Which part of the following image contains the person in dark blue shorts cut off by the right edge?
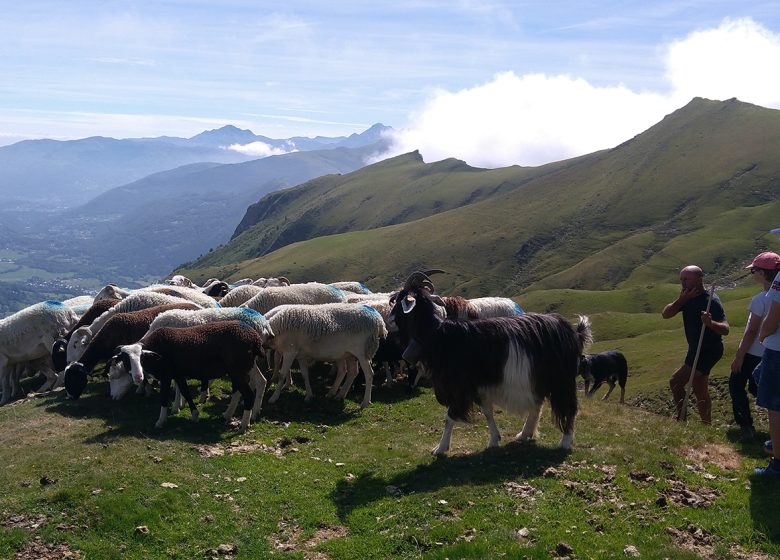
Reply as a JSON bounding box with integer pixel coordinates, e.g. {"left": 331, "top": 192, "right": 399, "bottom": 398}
{"left": 753, "top": 256, "right": 780, "bottom": 476}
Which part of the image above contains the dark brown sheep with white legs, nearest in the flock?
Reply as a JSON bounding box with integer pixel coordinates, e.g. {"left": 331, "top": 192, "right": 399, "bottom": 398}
{"left": 112, "top": 321, "right": 267, "bottom": 431}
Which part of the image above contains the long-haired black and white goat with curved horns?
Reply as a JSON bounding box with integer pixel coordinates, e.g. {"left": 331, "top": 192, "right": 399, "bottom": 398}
{"left": 392, "top": 280, "right": 591, "bottom": 455}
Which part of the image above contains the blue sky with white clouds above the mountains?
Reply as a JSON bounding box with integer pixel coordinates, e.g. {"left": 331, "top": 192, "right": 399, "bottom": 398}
{"left": 0, "top": 0, "right": 780, "bottom": 166}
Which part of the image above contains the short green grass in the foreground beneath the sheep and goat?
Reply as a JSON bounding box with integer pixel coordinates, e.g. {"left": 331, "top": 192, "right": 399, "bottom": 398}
{"left": 0, "top": 344, "right": 780, "bottom": 559}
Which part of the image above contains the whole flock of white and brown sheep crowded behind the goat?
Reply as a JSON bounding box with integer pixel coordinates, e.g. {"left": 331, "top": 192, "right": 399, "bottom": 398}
{"left": 0, "top": 271, "right": 523, "bottom": 440}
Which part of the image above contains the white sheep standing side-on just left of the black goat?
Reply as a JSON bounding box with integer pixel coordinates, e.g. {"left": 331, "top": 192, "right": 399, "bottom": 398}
{"left": 268, "top": 303, "right": 387, "bottom": 407}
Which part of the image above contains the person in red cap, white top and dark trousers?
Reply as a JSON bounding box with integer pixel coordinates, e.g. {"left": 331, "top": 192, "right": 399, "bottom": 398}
{"left": 729, "top": 251, "right": 780, "bottom": 438}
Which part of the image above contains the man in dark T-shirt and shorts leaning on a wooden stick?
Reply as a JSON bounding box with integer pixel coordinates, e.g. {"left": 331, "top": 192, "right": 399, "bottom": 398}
{"left": 661, "top": 265, "right": 729, "bottom": 424}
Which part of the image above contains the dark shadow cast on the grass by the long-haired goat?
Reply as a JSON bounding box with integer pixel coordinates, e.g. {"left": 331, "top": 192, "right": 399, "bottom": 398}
{"left": 331, "top": 442, "right": 569, "bottom": 521}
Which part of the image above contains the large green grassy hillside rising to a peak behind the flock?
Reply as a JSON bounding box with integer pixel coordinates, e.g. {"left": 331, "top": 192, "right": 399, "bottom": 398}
{"left": 179, "top": 99, "right": 780, "bottom": 295}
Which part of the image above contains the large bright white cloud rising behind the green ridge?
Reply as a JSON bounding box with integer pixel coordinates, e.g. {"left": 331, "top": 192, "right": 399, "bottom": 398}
{"left": 385, "top": 19, "right": 780, "bottom": 167}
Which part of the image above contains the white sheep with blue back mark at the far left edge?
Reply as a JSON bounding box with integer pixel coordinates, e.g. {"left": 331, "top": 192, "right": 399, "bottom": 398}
{"left": 0, "top": 301, "right": 78, "bottom": 404}
